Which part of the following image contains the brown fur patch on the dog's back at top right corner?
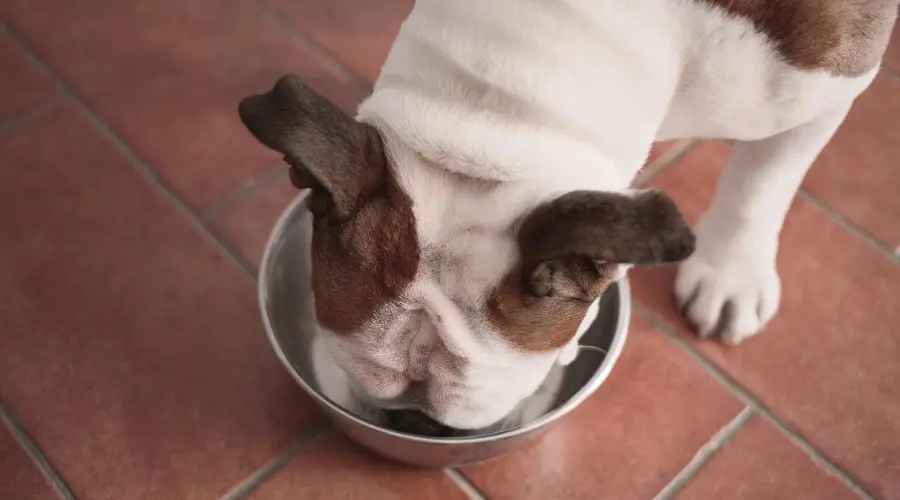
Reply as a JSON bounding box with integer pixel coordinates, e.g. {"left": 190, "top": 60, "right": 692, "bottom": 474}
{"left": 695, "top": 0, "right": 898, "bottom": 77}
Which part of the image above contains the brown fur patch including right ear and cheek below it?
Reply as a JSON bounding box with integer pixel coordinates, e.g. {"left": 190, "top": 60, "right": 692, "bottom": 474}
{"left": 487, "top": 191, "right": 694, "bottom": 352}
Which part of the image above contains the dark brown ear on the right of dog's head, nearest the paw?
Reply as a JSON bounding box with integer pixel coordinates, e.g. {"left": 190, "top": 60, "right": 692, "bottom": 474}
{"left": 518, "top": 190, "right": 694, "bottom": 301}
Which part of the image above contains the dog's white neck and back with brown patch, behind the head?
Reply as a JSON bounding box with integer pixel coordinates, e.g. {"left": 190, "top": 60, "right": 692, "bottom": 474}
{"left": 363, "top": 0, "right": 898, "bottom": 179}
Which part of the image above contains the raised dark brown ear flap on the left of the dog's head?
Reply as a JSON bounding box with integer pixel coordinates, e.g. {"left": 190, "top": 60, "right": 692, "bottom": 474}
{"left": 238, "top": 75, "right": 387, "bottom": 219}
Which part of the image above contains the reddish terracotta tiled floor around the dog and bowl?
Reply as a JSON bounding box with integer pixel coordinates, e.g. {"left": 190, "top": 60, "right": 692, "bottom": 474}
{"left": 0, "top": 0, "right": 900, "bottom": 500}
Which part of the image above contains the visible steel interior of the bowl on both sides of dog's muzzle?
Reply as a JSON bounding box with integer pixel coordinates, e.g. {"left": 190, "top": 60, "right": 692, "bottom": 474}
{"left": 259, "top": 195, "right": 630, "bottom": 439}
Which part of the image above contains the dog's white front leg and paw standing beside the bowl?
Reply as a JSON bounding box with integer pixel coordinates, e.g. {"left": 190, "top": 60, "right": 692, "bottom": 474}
{"left": 675, "top": 105, "right": 850, "bottom": 344}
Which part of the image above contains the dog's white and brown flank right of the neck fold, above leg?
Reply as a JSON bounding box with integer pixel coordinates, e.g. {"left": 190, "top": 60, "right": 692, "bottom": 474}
{"left": 657, "top": 0, "right": 898, "bottom": 140}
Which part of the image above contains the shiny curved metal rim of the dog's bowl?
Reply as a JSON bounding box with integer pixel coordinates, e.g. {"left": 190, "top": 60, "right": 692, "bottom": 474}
{"left": 256, "top": 190, "right": 631, "bottom": 445}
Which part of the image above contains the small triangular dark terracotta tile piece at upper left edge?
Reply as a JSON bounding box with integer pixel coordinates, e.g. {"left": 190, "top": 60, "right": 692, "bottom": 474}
{"left": 0, "top": 28, "right": 59, "bottom": 122}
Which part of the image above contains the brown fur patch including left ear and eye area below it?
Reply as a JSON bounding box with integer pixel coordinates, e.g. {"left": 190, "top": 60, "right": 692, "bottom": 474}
{"left": 238, "top": 76, "right": 420, "bottom": 333}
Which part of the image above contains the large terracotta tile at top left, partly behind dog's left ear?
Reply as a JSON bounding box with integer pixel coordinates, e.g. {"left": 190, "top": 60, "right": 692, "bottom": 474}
{"left": 0, "top": 0, "right": 362, "bottom": 210}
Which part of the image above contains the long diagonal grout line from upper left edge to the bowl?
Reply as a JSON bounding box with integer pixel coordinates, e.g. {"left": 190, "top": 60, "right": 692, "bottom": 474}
{"left": 0, "top": 21, "right": 256, "bottom": 279}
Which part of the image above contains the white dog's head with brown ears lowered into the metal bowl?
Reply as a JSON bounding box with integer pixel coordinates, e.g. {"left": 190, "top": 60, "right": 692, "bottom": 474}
{"left": 239, "top": 77, "right": 694, "bottom": 429}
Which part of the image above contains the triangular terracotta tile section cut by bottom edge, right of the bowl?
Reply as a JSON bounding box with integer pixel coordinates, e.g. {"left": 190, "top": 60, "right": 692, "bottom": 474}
{"left": 677, "top": 417, "right": 857, "bottom": 500}
